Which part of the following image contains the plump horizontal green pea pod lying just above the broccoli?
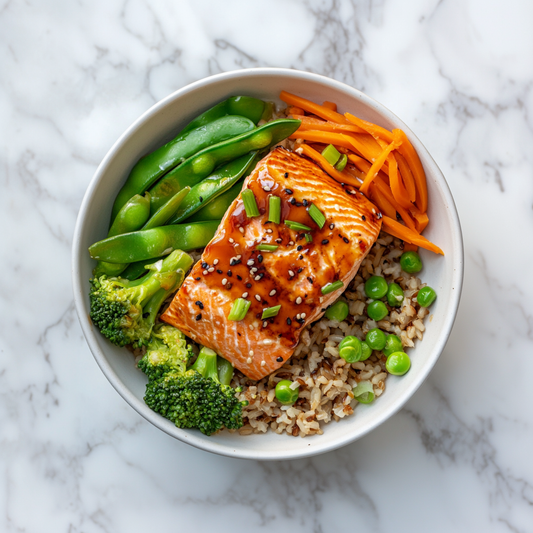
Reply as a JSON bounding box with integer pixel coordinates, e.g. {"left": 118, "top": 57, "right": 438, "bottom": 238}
{"left": 89, "top": 221, "right": 218, "bottom": 263}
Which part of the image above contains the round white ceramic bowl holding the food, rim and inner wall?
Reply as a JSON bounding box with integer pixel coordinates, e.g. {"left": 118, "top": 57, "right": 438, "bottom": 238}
{"left": 72, "top": 68, "right": 463, "bottom": 460}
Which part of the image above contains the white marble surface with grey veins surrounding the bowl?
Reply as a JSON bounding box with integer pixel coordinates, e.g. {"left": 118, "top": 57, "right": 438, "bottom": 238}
{"left": 0, "top": 0, "right": 533, "bottom": 533}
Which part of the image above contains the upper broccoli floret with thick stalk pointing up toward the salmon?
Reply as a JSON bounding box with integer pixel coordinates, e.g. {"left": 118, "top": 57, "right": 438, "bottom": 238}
{"left": 89, "top": 250, "right": 192, "bottom": 346}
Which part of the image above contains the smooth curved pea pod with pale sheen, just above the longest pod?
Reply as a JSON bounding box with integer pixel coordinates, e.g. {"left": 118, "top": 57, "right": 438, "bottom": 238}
{"left": 111, "top": 115, "right": 254, "bottom": 220}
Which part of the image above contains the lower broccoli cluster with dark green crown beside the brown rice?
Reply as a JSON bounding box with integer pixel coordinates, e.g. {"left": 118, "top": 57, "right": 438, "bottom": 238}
{"left": 139, "top": 326, "right": 246, "bottom": 435}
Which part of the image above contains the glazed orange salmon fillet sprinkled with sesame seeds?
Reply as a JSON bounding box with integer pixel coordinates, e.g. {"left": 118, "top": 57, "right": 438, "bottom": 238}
{"left": 161, "top": 148, "right": 381, "bottom": 380}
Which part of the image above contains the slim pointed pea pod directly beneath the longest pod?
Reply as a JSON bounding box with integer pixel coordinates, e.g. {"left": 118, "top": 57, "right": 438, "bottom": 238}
{"left": 165, "top": 152, "right": 262, "bottom": 224}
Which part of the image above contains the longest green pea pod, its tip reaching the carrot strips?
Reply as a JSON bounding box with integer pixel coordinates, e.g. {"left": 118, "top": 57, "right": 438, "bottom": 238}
{"left": 150, "top": 119, "right": 300, "bottom": 212}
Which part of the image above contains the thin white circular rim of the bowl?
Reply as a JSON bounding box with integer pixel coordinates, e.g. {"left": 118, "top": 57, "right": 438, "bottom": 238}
{"left": 72, "top": 67, "right": 464, "bottom": 460}
